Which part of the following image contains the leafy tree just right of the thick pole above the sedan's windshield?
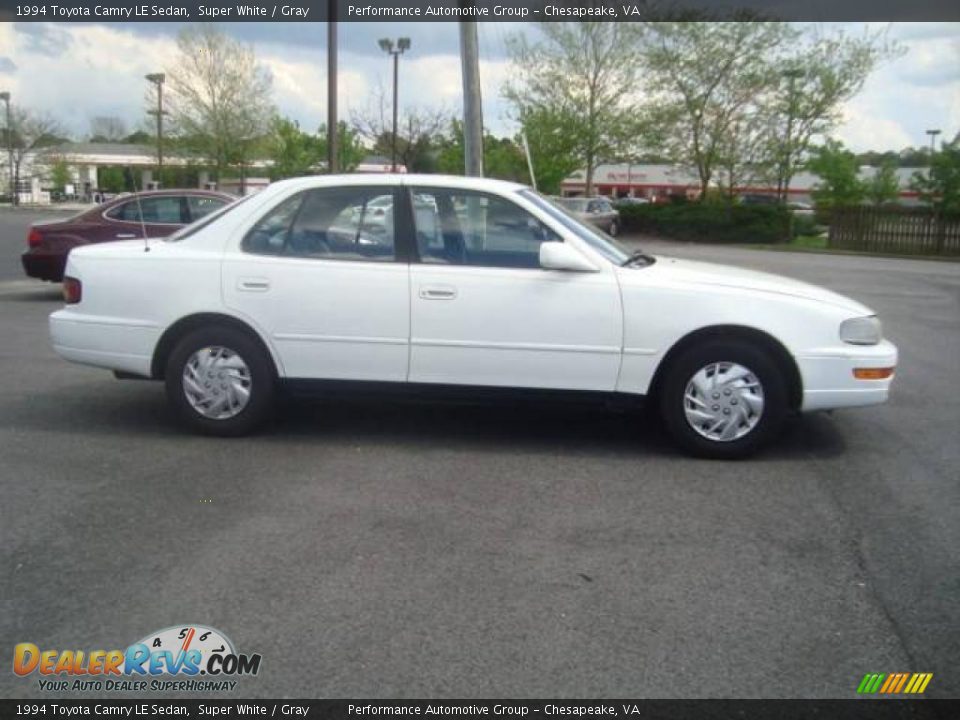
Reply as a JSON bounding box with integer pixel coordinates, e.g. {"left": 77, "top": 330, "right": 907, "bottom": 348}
{"left": 503, "top": 22, "right": 641, "bottom": 195}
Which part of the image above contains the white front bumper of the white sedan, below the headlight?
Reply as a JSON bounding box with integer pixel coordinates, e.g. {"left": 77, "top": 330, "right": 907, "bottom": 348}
{"left": 796, "top": 340, "right": 898, "bottom": 411}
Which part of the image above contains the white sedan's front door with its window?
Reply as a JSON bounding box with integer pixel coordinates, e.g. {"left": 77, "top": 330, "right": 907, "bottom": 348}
{"left": 409, "top": 187, "right": 622, "bottom": 390}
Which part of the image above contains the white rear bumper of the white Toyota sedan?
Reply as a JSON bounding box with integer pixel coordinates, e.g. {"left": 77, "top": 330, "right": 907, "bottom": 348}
{"left": 50, "top": 309, "right": 160, "bottom": 377}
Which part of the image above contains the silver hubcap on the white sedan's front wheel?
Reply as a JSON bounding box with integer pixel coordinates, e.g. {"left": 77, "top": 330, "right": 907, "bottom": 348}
{"left": 683, "top": 362, "right": 763, "bottom": 442}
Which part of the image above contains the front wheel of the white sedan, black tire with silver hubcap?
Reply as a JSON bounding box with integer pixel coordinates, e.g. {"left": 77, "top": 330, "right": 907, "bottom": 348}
{"left": 660, "top": 340, "right": 788, "bottom": 459}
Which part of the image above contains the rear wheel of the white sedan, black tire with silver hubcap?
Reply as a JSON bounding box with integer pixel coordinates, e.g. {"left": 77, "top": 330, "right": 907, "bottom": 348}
{"left": 164, "top": 325, "right": 276, "bottom": 437}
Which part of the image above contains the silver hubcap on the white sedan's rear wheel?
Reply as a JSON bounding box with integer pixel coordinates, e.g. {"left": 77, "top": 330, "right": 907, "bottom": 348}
{"left": 183, "top": 346, "right": 251, "bottom": 420}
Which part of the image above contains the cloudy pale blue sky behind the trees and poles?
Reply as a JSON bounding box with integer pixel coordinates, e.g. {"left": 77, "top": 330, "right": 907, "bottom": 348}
{"left": 0, "top": 22, "right": 960, "bottom": 152}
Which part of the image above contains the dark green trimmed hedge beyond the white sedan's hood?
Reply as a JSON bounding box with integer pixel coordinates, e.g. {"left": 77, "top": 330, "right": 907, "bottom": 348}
{"left": 620, "top": 202, "right": 790, "bottom": 243}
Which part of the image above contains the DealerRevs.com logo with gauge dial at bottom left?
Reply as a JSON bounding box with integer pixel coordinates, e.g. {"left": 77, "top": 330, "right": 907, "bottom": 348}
{"left": 13, "top": 624, "right": 261, "bottom": 692}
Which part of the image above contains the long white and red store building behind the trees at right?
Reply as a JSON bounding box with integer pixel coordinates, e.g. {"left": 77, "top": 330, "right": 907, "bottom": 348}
{"left": 560, "top": 164, "right": 926, "bottom": 205}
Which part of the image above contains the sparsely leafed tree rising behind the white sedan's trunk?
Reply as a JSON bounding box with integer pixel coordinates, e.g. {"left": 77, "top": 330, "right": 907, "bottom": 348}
{"left": 167, "top": 25, "right": 275, "bottom": 186}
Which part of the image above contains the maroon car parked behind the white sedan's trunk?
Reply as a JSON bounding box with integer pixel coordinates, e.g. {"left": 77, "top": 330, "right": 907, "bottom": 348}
{"left": 21, "top": 190, "right": 236, "bottom": 282}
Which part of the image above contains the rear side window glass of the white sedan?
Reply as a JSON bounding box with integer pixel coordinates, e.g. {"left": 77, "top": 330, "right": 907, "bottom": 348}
{"left": 243, "top": 187, "right": 394, "bottom": 260}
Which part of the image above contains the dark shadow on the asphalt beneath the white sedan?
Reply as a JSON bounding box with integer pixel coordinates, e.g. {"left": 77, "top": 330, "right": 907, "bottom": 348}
{"left": 0, "top": 381, "right": 846, "bottom": 462}
